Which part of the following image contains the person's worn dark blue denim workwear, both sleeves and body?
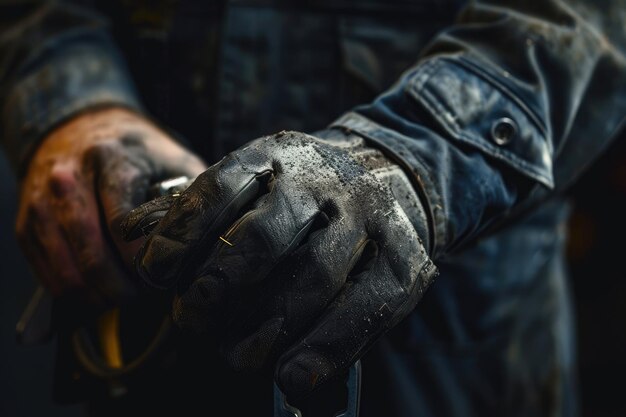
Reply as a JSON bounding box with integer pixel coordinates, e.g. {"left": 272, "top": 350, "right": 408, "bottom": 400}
{"left": 0, "top": 0, "right": 626, "bottom": 417}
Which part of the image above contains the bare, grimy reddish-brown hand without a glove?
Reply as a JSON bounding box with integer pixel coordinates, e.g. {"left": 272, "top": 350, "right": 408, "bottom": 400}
{"left": 16, "top": 108, "right": 206, "bottom": 312}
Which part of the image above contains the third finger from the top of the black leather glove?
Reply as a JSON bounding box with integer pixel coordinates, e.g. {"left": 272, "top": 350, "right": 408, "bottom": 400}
{"left": 217, "top": 221, "right": 368, "bottom": 369}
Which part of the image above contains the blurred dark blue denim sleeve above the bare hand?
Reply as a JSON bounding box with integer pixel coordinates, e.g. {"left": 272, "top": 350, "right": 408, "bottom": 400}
{"left": 0, "top": 1, "right": 141, "bottom": 176}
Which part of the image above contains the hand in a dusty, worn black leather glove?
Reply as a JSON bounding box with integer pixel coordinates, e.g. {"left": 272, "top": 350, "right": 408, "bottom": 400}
{"left": 125, "top": 131, "right": 436, "bottom": 399}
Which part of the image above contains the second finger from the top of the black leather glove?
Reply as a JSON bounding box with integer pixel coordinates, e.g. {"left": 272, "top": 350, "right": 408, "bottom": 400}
{"left": 174, "top": 182, "right": 328, "bottom": 333}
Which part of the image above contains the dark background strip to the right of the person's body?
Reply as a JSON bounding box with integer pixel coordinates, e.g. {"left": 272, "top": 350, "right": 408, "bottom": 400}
{"left": 568, "top": 129, "right": 626, "bottom": 417}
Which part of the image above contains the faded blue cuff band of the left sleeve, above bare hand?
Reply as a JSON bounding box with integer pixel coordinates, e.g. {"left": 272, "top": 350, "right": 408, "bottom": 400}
{"left": 1, "top": 39, "right": 143, "bottom": 178}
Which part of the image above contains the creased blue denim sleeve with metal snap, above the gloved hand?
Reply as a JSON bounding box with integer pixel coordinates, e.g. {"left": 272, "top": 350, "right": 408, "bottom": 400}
{"left": 331, "top": 0, "right": 626, "bottom": 256}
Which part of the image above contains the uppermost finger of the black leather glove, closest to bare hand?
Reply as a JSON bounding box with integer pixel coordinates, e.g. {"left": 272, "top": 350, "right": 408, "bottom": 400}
{"left": 135, "top": 150, "right": 274, "bottom": 288}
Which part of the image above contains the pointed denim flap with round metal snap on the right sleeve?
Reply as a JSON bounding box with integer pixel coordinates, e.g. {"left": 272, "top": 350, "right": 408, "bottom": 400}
{"left": 405, "top": 55, "right": 554, "bottom": 189}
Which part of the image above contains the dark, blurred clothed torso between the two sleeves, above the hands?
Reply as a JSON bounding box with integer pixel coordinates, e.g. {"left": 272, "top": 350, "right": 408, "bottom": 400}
{"left": 102, "top": 0, "right": 461, "bottom": 162}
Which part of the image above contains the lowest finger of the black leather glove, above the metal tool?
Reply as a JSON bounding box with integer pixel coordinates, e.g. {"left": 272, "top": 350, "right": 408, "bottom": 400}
{"left": 276, "top": 245, "right": 430, "bottom": 399}
